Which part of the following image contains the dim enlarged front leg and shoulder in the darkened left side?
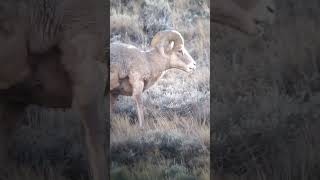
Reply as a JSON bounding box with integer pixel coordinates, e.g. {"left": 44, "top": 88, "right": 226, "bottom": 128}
{"left": 61, "top": 34, "right": 109, "bottom": 180}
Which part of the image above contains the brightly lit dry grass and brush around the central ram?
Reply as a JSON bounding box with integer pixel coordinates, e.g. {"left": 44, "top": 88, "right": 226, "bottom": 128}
{"left": 111, "top": 0, "right": 210, "bottom": 179}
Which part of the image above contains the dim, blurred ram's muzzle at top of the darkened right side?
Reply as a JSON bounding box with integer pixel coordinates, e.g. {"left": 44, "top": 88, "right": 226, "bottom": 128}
{"left": 211, "top": 0, "right": 275, "bottom": 35}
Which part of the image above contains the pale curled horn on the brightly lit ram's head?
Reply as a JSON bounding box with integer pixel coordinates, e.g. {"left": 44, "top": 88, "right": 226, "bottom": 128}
{"left": 151, "top": 30, "right": 184, "bottom": 49}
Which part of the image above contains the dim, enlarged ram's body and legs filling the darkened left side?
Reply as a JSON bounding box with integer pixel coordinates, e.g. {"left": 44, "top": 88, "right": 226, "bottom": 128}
{"left": 0, "top": 0, "right": 109, "bottom": 180}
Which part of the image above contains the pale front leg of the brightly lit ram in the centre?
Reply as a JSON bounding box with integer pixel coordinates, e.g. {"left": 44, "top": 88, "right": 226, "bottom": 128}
{"left": 130, "top": 81, "right": 144, "bottom": 128}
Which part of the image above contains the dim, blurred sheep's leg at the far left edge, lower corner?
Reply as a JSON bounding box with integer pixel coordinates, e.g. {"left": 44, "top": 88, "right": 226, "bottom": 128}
{"left": 0, "top": 103, "right": 24, "bottom": 174}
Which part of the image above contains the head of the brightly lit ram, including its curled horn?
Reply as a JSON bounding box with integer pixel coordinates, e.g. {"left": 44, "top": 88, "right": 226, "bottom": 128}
{"left": 151, "top": 30, "right": 196, "bottom": 72}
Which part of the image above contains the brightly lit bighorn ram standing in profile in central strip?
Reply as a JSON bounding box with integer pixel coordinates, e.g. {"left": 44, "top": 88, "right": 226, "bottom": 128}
{"left": 110, "top": 30, "right": 196, "bottom": 127}
